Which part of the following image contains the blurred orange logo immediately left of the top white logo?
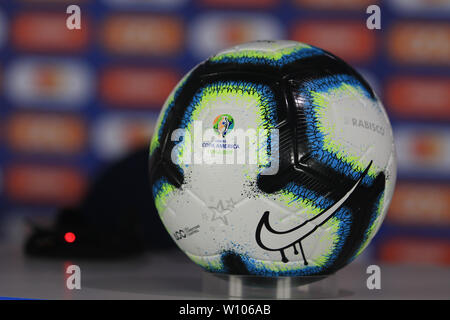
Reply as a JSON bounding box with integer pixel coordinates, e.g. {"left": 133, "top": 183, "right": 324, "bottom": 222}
{"left": 102, "top": 14, "right": 183, "bottom": 55}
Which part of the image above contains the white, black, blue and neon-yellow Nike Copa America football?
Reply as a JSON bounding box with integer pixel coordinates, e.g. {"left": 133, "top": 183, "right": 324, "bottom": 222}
{"left": 149, "top": 41, "right": 396, "bottom": 277}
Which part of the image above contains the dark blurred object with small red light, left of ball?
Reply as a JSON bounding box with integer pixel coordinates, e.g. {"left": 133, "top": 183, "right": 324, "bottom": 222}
{"left": 25, "top": 148, "right": 175, "bottom": 258}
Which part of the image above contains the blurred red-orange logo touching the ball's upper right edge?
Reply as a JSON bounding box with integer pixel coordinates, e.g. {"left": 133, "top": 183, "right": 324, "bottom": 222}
{"left": 292, "top": 20, "right": 376, "bottom": 62}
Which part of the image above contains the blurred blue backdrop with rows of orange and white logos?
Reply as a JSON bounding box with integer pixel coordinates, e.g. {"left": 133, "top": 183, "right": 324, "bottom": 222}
{"left": 0, "top": 0, "right": 450, "bottom": 265}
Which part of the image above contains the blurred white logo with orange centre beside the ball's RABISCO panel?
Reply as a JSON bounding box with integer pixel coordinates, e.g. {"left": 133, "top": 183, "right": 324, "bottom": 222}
{"left": 394, "top": 126, "right": 450, "bottom": 175}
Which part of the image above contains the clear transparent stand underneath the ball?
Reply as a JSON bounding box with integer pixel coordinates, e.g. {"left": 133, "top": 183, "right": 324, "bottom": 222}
{"left": 202, "top": 272, "right": 339, "bottom": 299}
